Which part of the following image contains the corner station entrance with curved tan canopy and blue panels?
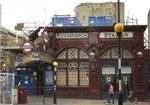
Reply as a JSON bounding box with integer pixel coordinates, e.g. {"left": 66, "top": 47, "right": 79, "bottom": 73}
{"left": 16, "top": 52, "right": 53, "bottom": 95}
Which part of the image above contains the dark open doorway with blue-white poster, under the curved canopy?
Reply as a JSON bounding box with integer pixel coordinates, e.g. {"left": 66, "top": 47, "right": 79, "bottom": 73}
{"left": 34, "top": 64, "right": 53, "bottom": 95}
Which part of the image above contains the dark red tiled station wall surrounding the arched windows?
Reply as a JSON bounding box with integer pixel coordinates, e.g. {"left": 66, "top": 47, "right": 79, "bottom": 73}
{"left": 29, "top": 25, "right": 146, "bottom": 100}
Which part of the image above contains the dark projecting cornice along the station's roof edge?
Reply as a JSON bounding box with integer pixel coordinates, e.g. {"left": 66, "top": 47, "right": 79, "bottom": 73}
{"left": 29, "top": 25, "right": 147, "bottom": 40}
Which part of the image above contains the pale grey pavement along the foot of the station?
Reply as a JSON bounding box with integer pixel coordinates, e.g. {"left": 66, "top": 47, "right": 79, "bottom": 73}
{"left": 14, "top": 96, "right": 150, "bottom": 105}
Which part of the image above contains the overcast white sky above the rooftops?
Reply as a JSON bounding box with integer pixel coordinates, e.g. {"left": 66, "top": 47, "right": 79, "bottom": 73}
{"left": 0, "top": 0, "right": 150, "bottom": 30}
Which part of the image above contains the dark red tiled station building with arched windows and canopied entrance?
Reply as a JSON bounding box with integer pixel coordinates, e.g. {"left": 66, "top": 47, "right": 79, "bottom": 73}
{"left": 16, "top": 25, "right": 150, "bottom": 100}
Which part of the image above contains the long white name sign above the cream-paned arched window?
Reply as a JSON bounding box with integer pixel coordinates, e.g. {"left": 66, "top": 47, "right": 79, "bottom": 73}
{"left": 56, "top": 33, "right": 88, "bottom": 39}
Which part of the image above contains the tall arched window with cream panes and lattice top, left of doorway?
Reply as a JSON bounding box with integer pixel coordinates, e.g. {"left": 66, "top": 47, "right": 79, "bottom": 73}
{"left": 57, "top": 47, "right": 89, "bottom": 86}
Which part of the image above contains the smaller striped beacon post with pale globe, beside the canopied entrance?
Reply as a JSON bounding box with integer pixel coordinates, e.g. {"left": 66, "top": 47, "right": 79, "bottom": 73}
{"left": 53, "top": 61, "right": 58, "bottom": 104}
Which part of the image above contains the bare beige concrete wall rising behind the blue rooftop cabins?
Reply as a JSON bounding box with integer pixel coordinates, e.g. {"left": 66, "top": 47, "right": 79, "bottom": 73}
{"left": 75, "top": 2, "right": 125, "bottom": 26}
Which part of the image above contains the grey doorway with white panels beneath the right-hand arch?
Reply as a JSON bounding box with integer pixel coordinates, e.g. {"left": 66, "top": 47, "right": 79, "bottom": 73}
{"left": 100, "top": 66, "right": 133, "bottom": 98}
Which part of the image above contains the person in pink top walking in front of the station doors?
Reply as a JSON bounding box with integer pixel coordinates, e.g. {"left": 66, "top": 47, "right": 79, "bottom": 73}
{"left": 108, "top": 82, "right": 115, "bottom": 104}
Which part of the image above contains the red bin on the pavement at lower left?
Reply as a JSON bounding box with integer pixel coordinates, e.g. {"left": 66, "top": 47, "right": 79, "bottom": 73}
{"left": 18, "top": 87, "right": 27, "bottom": 104}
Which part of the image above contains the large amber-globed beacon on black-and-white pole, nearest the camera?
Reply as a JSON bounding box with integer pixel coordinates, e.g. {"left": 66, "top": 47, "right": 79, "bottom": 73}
{"left": 114, "top": 23, "right": 124, "bottom": 105}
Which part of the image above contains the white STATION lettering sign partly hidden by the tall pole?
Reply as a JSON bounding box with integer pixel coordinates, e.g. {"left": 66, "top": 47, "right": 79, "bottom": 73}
{"left": 99, "top": 32, "right": 133, "bottom": 38}
